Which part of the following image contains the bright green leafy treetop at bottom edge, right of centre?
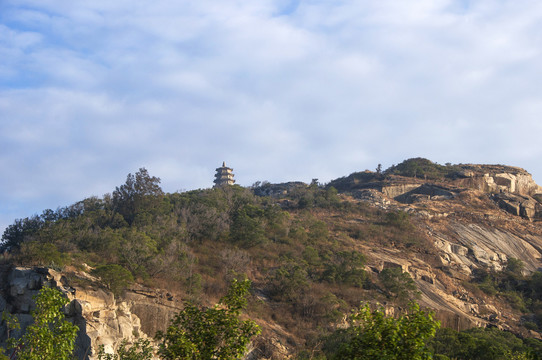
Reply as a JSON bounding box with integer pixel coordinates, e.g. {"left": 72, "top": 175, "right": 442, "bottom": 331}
{"left": 328, "top": 303, "right": 440, "bottom": 360}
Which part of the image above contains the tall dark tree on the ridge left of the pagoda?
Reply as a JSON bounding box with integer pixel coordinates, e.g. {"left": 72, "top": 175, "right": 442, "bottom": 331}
{"left": 113, "top": 168, "right": 164, "bottom": 224}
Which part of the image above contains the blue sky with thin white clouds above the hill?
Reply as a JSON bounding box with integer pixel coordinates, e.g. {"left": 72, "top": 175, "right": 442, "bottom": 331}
{"left": 0, "top": 0, "right": 542, "bottom": 233}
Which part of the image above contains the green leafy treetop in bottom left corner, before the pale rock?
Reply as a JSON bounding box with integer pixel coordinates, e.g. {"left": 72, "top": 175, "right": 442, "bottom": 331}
{"left": 2, "top": 287, "right": 78, "bottom": 360}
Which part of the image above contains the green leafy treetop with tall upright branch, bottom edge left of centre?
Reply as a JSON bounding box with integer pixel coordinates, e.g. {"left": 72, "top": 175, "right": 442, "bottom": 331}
{"left": 157, "top": 280, "right": 260, "bottom": 360}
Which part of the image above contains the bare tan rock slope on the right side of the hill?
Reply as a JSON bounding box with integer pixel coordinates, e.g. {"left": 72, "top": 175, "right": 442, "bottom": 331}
{"left": 332, "top": 165, "right": 542, "bottom": 337}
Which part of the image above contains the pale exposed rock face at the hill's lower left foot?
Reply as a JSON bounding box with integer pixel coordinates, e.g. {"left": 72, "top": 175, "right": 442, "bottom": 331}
{"left": 0, "top": 267, "right": 180, "bottom": 360}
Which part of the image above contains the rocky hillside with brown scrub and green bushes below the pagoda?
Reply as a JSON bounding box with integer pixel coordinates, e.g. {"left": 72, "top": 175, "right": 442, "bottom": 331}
{"left": 0, "top": 158, "right": 542, "bottom": 359}
